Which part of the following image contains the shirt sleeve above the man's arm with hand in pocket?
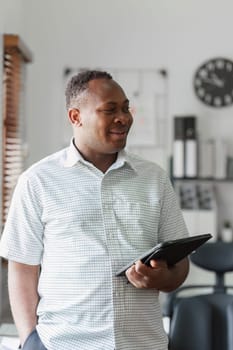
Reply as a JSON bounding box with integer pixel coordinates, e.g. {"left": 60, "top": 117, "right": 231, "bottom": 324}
{"left": 0, "top": 174, "right": 44, "bottom": 265}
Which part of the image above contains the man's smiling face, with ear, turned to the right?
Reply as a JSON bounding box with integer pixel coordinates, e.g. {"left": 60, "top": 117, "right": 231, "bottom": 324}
{"left": 74, "top": 79, "right": 133, "bottom": 155}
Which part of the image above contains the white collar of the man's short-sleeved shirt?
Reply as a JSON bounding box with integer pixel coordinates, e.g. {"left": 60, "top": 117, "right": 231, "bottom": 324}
{"left": 63, "top": 139, "right": 136, "bottom": 170}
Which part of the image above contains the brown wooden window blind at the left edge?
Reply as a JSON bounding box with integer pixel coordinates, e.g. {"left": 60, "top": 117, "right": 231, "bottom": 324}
{"left": 2, "top": 34, "right": 31, "bottom": 225}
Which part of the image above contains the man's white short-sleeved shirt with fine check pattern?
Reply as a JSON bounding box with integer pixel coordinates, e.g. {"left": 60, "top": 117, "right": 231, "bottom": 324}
{"left": 0, "top": 143, "right": 187, "bottom": 350}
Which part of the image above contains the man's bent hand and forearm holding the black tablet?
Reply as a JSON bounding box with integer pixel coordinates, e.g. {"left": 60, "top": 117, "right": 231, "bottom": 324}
{"left": 126, "top": 258, "right": 189, "bottom": 292}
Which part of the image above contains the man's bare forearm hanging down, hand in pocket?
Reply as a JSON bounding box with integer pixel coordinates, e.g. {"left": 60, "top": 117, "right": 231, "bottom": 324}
{"left": 8, "top": 261, "right": 39, "bottom": 344}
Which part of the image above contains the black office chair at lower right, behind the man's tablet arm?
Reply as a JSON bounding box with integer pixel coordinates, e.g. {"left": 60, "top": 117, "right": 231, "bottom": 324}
{"left": 163, "top": 241, "right": 233, "bottom": 350}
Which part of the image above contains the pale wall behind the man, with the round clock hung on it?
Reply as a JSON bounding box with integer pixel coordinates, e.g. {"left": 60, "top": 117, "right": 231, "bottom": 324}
{"left": 18, "top": 0, "right": 233, "bottom": 162}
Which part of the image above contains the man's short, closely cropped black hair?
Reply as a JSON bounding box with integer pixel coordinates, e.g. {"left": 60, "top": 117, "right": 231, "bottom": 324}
{"left": 65, "top": 70, "right": 112, "bottom": 109}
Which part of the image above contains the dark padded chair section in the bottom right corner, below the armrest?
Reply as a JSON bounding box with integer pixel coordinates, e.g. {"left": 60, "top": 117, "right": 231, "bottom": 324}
{"left": 169, "top": 294, "right": 233, "bottom": 350}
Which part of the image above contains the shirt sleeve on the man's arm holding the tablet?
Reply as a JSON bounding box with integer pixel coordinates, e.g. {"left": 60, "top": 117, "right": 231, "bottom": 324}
{"left": 158, "top": 175, "right": 188, "bottom": 242}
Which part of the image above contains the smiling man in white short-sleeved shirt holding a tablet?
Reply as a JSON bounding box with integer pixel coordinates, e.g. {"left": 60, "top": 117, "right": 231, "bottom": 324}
{"left": 1, "top": 71, "right": 188, "bottom": 350}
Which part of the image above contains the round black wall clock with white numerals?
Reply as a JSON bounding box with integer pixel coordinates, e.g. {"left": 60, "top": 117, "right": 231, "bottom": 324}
{"left": 194, "top": 57, "right": 233, "bottom": 108}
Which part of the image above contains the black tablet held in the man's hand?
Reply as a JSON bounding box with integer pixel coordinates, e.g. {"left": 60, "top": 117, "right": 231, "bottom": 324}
{"left": 116, "top": 233, "right": 212, "bottom": 276}
